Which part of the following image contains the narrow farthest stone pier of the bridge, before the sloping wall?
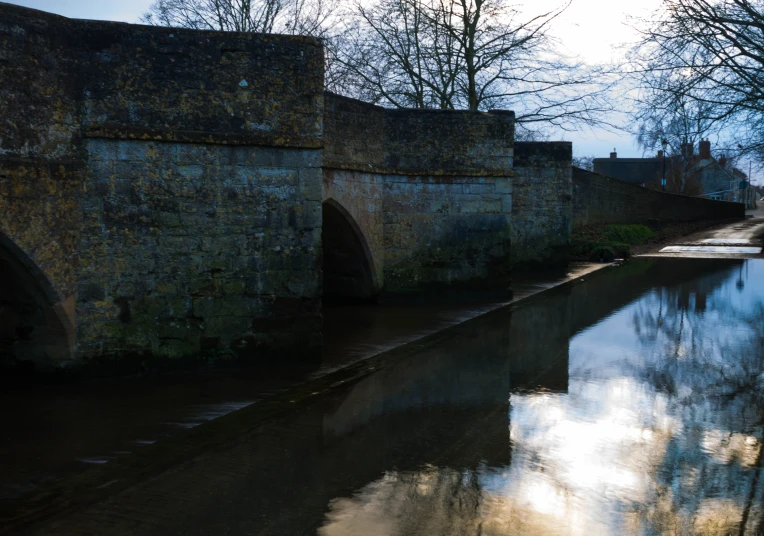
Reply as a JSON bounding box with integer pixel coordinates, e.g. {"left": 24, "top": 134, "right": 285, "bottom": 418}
{"left": 512, "top": 142, "right": 573, "bottom": 266}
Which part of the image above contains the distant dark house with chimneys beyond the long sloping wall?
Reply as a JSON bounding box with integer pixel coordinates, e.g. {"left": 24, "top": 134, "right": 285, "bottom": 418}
{"left": 593, "top": 140, "right": 758, "bottom": 208}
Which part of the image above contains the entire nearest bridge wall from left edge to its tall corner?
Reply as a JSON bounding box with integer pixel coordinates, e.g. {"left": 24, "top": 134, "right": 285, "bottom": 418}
{"left": 0, "top": 4, "right": 323, "bottom": 368}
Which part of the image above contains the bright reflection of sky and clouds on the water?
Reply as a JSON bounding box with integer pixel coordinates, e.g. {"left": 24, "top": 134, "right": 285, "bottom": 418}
{"left": 320, "top": 260, "right": 764, "bottom": 535}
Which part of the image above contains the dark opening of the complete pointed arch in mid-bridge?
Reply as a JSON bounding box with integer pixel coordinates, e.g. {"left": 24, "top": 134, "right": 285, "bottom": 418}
{"left": 321, "top": 198, "right": 379, "bottom": 301}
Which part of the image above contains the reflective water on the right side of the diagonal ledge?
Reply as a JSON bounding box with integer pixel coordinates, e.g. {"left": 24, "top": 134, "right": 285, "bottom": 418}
{"left": 13, "top": 259, "right": 764, "bottom": 536}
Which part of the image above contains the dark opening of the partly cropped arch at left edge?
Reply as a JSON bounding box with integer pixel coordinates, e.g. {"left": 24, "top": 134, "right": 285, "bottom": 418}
{"left": 0, "top": 233, "right": 75, "bottom": 372}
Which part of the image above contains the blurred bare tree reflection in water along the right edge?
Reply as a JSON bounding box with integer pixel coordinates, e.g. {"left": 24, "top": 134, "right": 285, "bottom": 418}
{"left": 631, "top": 270, "right": 764, "bottom": 534}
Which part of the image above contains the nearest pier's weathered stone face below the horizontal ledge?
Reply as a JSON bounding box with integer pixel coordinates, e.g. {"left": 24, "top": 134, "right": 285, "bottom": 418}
{"left": 78, "top": 140, "right": 321, "bottom": 357}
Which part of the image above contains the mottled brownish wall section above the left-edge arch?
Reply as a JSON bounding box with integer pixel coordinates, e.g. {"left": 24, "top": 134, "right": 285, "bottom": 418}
{"left": 0, "top": 4, "right": 83, "bottom": 300}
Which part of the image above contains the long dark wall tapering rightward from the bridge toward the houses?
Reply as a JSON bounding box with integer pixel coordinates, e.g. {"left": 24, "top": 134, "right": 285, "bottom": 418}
{"left": 573, "top": 168, "right": 745, "bottom": 226}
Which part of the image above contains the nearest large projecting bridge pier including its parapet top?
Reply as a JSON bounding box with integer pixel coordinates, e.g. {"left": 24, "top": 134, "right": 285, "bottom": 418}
{"left": 78, "top": 25, "right": 323, "bottom": 364}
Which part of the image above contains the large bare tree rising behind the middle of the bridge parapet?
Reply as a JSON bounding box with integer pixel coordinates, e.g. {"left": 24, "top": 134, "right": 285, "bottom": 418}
{"left": 338, "top": 0, "right": 611, "bottom": 134}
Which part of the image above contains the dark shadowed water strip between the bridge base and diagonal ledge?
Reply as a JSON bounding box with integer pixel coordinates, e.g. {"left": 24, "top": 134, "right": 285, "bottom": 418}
{"left": 0, "top": 263, "right": 601, "bottom": 502}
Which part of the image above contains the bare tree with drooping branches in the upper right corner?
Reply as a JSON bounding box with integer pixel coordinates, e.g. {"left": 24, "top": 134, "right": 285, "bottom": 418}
{"left": 632, "top": 0, "right": 764, "bottom": 161}
